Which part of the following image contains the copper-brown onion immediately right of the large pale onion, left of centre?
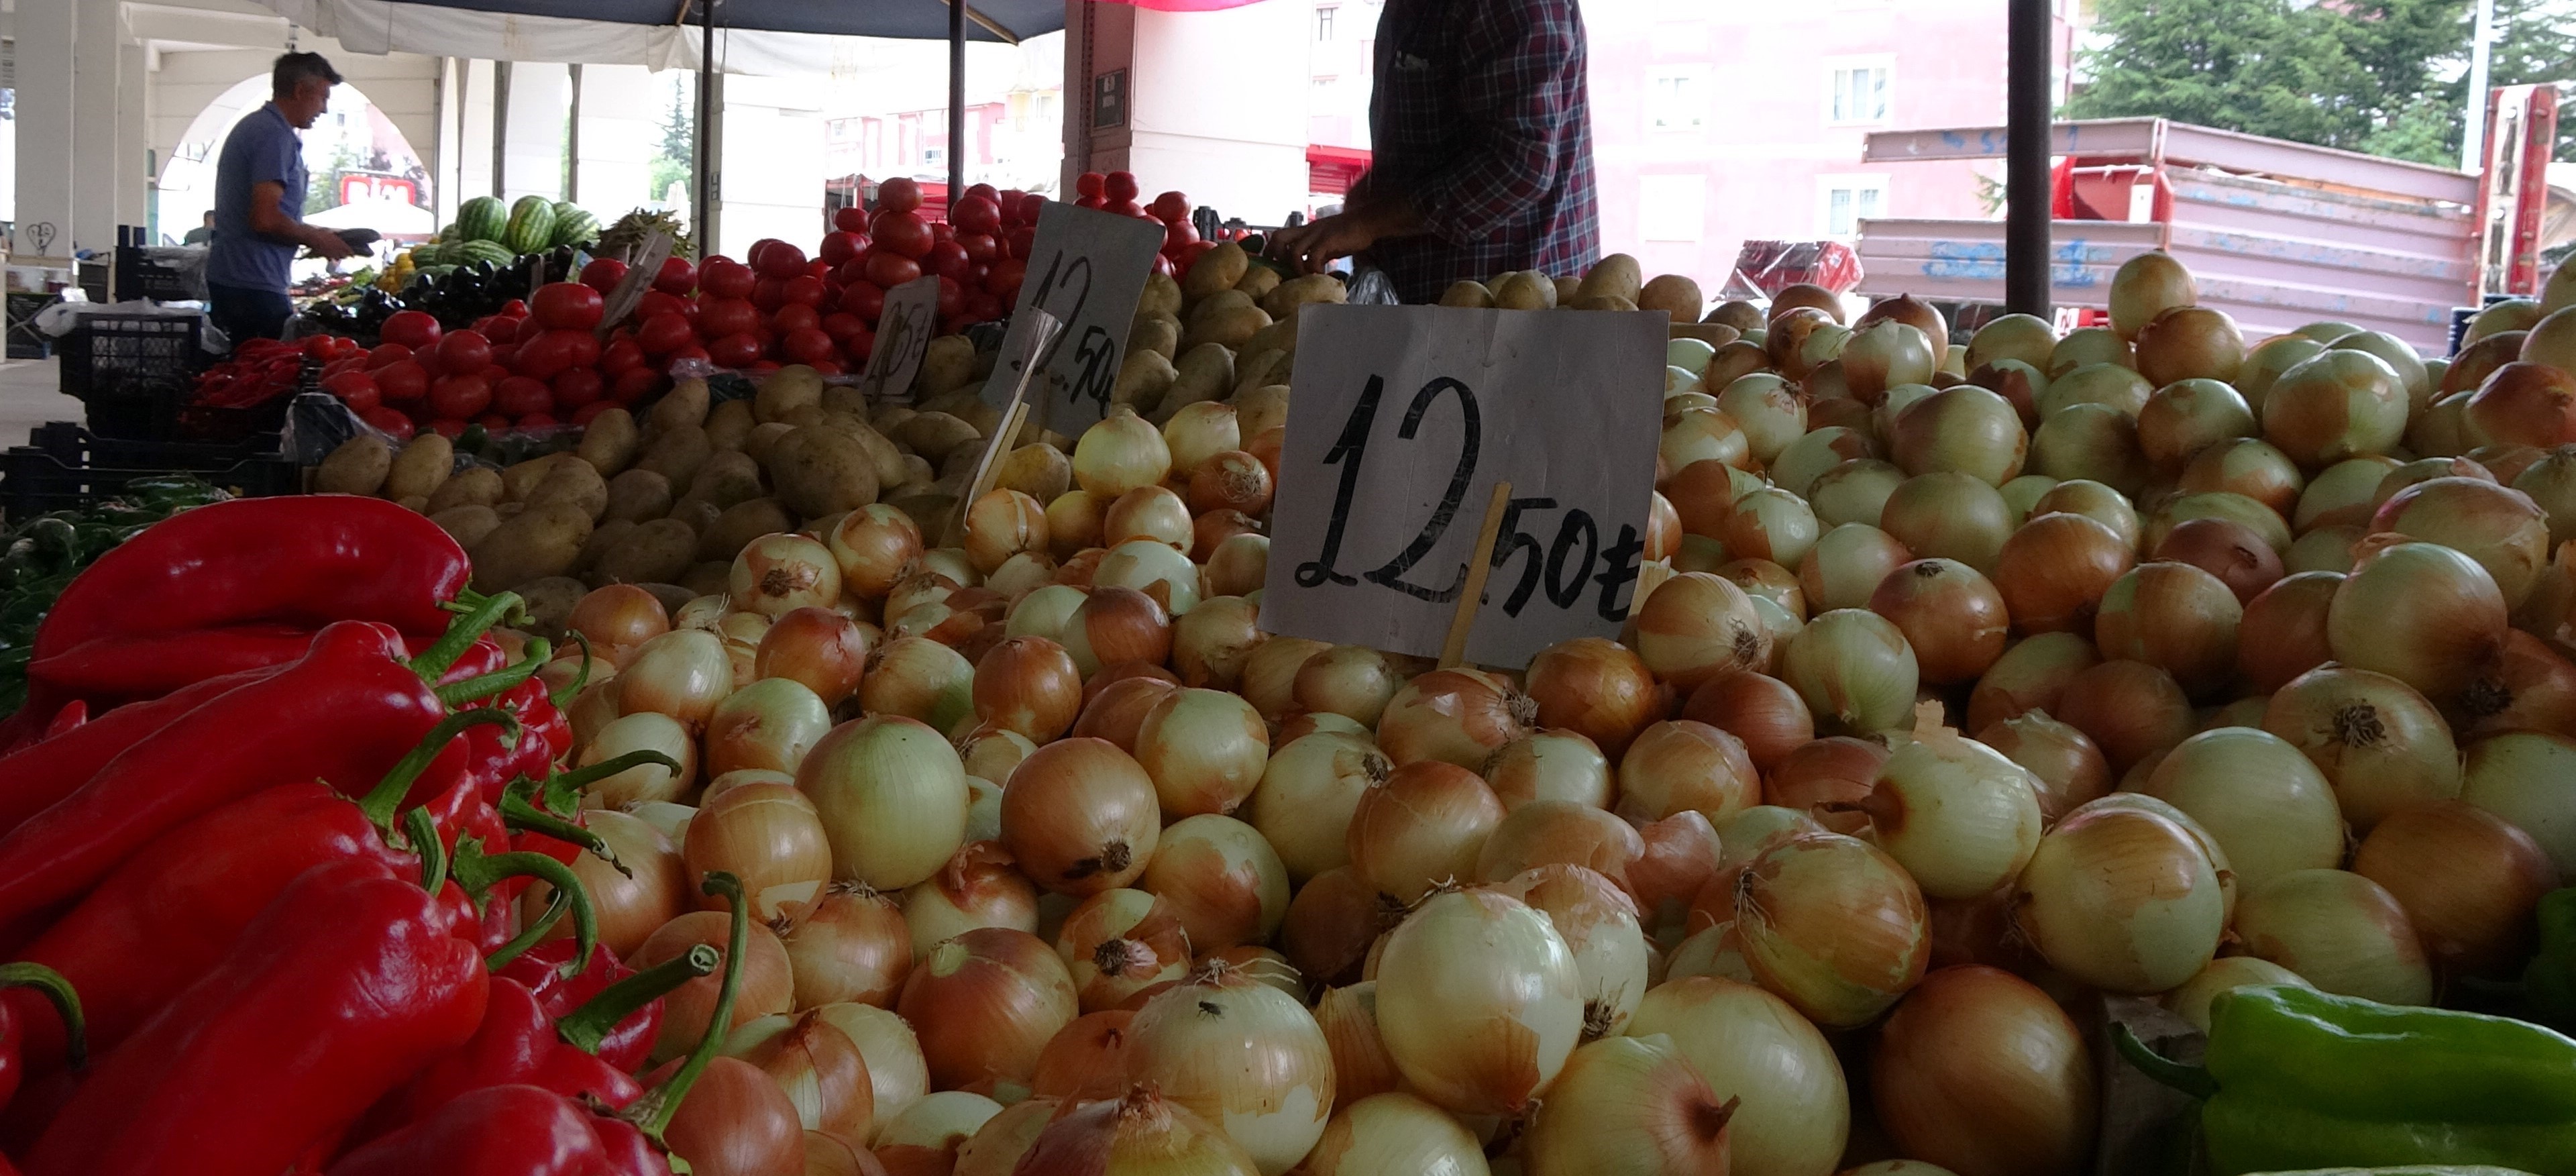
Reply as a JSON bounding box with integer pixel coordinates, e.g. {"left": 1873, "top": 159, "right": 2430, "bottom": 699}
{"left": 1002, "top": 739, "right": 1162, "bottom": 898}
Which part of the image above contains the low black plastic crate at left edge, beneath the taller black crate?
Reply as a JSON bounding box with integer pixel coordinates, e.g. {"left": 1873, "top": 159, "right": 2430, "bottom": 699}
{"left": 0, "top": 422, "right": 304, "bottom": 520}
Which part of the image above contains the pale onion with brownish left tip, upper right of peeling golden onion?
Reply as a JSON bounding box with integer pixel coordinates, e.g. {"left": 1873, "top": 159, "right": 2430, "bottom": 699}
{"left": 1860, "top": 729, "right": 2043, "bottom": 898}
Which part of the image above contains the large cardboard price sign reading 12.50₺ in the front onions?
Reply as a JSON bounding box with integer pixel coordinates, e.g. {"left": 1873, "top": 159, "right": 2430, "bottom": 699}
{"left": 1263, "top": 306, "right": 1666, "bottom": 666}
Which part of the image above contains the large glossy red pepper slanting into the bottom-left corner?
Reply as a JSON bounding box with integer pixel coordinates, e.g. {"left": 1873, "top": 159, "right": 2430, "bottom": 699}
{"left": 25, "top": 862, "right": 490, "bottom": 1176}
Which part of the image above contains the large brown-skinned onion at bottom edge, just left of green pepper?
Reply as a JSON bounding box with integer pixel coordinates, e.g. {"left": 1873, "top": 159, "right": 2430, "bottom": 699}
{"left": 1870, "top": 962, "right": 2092, "bottom": 1173}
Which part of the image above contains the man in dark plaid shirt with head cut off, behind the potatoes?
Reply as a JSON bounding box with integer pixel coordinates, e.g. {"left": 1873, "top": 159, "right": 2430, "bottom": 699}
{"left": 1270, "top": 0, "right": 1600, "bottom": 304}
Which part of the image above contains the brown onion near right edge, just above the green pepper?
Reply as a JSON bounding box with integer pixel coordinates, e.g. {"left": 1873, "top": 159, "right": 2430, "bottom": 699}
{"left": 2352, "top": 800, "right": 2558, "bottom": 978}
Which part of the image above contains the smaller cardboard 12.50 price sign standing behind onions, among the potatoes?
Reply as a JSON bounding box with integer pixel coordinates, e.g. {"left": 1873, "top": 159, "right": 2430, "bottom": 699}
{"left": 984, "top": 201, "right": 1162, "bottom": 437}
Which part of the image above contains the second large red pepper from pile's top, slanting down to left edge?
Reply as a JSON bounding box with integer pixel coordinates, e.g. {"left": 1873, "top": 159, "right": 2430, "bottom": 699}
{"left": 0, "top": 617, "right": 445, "bottom": 926}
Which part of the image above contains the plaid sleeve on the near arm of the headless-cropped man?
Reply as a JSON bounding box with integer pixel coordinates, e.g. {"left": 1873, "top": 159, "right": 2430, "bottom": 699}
{"left": 1411, "top": 0, "right": 1585, "bottom": 242}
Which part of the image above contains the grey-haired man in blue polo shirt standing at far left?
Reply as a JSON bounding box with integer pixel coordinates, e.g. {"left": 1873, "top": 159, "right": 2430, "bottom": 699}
{"left": 206, "top": 54, "right": 350, "bottom": 342}
